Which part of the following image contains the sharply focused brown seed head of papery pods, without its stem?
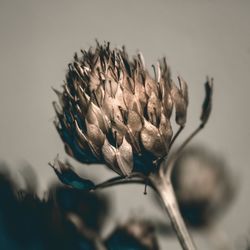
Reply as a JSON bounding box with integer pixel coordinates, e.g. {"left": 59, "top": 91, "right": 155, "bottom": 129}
{"left": 54, "top": 43, "right": 188, "bottom": 176}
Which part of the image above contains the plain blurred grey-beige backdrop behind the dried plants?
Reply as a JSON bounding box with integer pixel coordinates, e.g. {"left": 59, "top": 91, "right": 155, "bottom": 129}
{"left": 0, "top": 0, "right": 250, "bottom": 249}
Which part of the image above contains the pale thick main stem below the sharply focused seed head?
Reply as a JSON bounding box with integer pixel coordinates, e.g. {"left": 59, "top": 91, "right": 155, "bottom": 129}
{"left": 150, "top": 174, "right": 196, "bottom": 250}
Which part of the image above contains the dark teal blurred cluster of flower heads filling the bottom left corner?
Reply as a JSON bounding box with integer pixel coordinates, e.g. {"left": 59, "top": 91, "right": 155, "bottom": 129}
{"left": 0, "top": 163, "right": 158, "bottom": 250}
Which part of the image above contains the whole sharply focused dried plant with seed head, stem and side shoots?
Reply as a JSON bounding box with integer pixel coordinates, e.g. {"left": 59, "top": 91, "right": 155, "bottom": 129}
{"left": 50, "top": 42, "right": 212, "bottom": 249}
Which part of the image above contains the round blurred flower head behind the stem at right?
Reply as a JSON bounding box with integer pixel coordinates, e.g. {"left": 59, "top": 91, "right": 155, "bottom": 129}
{"left": 173, "top": 145, "right": 237, "bottom": 228}
